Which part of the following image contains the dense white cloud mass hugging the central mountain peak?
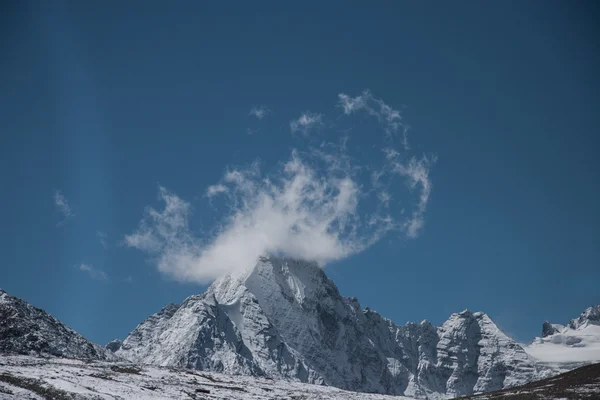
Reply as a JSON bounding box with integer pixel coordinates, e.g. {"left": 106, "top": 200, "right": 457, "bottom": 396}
{"left": 125, "top": 152, "right": 379, "bottom": 282}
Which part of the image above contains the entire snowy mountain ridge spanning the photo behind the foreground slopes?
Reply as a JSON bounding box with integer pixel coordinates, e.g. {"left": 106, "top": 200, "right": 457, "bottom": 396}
{"left": 0, "top": 257, "right": 600, "bottom": 399}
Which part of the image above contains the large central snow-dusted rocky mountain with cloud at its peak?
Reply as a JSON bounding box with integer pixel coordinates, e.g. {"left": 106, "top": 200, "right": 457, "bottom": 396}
{"left": 113, "top": 257, "right": 537, "bottom": 398}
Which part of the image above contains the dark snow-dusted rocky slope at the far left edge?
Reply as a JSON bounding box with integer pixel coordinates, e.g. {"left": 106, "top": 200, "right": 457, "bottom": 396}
{"left": 0, "top": 289, "right": 115, "bottom": 360}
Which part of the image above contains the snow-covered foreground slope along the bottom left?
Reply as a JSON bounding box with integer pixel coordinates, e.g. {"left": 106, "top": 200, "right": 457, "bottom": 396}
{"left": 0, "top": 356, "right": 410, "bottom": 400}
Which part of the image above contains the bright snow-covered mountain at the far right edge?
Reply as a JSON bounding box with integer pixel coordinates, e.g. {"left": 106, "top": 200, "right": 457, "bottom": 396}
{"left": 524, "top": 306, "right": 600, "bottom": 376}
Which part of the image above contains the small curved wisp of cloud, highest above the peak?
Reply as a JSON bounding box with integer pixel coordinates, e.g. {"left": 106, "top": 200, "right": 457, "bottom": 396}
{"left": 338, "top": 90, "right": 409, "bottom": 149}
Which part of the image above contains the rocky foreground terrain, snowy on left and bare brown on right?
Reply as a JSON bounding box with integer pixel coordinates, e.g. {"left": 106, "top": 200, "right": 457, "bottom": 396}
{"left": 0, "top": 356, "right": 600, "bottom": 400}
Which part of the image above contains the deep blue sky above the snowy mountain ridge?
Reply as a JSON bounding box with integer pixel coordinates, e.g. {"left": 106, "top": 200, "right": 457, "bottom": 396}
{"left": 0, "top": 1, "right": 600, "bottom": 343}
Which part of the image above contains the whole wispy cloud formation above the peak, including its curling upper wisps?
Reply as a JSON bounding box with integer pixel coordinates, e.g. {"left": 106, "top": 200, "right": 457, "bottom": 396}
{"left": 124, "top": 92, "right": 435, "bottom": 282}
